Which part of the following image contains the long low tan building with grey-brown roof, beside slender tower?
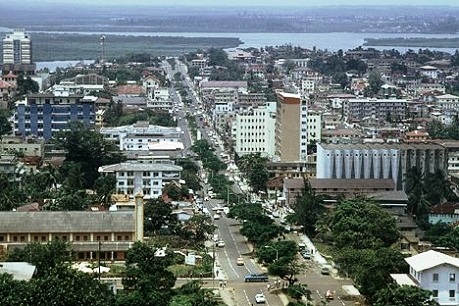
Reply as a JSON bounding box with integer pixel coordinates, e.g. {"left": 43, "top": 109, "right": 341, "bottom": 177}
{"left": 0, "top": 211, "right": 136, "bottom": 261}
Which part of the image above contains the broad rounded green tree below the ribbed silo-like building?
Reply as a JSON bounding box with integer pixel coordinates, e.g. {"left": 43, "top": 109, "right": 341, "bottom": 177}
{"left": 331, "top": 197, "right": 399, "bottom": 249}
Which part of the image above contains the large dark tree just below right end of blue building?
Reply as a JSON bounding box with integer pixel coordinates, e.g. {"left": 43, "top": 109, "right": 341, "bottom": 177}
{"left": 55, "top": 124, "right": 125, "bottom": 188}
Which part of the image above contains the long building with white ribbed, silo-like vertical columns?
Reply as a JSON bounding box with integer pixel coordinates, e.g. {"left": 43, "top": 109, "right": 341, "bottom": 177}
{"left": 317, "top": 143, "right": 448, "bottom": 190}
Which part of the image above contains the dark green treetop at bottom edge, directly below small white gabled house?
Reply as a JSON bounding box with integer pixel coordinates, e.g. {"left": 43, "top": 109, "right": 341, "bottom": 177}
{"left": 373, "top": 285, "right": 439, "bottom": 306}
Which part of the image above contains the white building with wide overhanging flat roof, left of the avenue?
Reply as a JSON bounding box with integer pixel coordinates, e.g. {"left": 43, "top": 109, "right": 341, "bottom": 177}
{"left": 99, "top": 161, "right": 182, "bottom": 199}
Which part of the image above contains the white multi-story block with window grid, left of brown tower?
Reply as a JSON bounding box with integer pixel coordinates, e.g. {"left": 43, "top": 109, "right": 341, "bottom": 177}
{"left": 232, "top": 107, "right": 276, "bottom": 157}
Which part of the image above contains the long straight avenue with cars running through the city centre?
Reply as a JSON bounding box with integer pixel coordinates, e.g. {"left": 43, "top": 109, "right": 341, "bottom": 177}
{"left": 166, "top": 61, "right": 353, "bottom": 306}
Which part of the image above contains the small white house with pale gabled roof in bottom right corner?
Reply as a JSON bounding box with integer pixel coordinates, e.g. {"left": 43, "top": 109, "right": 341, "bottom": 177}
{"left": 391, "top": 250, "right": 459, "bottom": 306}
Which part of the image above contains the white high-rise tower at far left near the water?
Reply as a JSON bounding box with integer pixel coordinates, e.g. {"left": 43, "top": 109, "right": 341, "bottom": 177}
{"left": 3, "top": 29, "right": 36, "bottom": 75}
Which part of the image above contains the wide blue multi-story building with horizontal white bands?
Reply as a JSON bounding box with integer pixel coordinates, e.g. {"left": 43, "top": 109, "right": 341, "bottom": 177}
{"left": 14, "top": 93, "right": 95, "bottom": 139}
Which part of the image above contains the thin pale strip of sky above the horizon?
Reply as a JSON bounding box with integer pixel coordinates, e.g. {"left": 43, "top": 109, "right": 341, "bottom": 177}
{"left": 22, "top": 0, "right": 459, "bottom": 7}
